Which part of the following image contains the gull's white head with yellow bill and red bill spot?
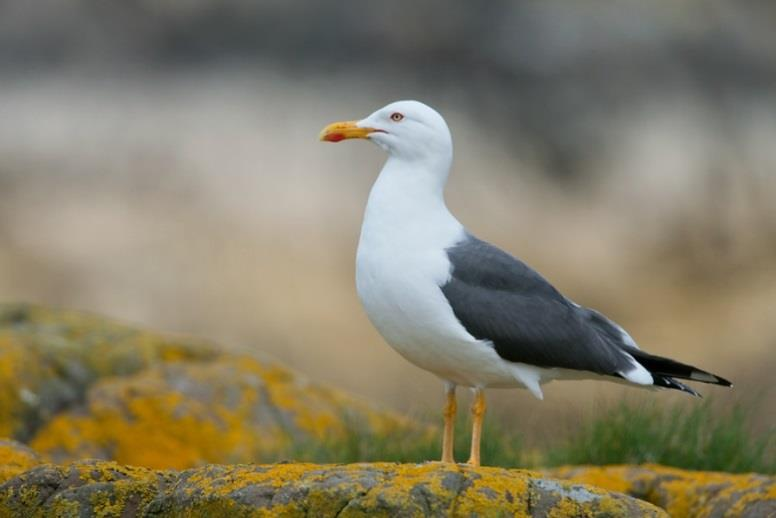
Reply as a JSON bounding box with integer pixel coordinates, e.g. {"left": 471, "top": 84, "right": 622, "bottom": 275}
{"left": 320, "top": 101, "right": 453, "bottom": 164}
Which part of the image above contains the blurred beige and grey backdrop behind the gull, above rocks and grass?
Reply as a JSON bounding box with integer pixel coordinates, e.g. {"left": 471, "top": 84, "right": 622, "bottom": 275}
{"left": 0, "top": 0, "right": 776, "bottom": 444}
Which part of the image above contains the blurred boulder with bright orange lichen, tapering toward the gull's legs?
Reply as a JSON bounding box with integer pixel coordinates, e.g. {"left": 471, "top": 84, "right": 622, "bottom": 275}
{"left": 30, "top": 357, "right": 416, "bottom": 469}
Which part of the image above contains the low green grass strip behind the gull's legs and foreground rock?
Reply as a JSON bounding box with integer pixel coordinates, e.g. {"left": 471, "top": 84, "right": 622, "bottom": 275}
{"left": 287, "top": 401, "right": 776, "bottom": 474}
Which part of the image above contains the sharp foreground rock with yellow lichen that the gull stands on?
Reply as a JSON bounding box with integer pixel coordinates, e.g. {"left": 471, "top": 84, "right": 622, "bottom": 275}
{"left": 0, "top": 461, "right": 666, "bottom": 518}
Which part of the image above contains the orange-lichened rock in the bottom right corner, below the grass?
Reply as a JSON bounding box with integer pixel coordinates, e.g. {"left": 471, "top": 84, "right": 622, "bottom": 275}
{"left": 544, "top": 465, "right": 776, "bottom": 518}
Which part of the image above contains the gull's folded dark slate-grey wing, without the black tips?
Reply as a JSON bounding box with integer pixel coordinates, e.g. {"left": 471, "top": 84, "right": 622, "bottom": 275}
{"left": 441, "top": 236, "right": 633, "bottom": 375}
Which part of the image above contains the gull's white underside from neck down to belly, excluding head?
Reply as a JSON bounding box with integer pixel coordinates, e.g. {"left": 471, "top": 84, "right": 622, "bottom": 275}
{"left": 356, "top": 160, "right": 516, "bottom": 386}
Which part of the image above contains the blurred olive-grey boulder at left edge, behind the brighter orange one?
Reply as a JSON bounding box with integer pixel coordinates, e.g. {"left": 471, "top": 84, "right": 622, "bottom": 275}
{"left": 0, "top": 304, "right": 217, "bottom": 441}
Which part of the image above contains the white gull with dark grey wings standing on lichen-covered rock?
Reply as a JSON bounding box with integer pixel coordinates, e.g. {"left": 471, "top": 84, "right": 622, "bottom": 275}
{"left": 319, "top": 101, "right": 732, "bottom": 466}
